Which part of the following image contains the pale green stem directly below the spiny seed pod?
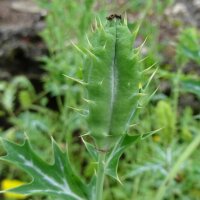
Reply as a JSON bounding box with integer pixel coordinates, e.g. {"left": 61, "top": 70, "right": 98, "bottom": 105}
{"left": 96, "top": 152, "right": 105, "bottom": 200}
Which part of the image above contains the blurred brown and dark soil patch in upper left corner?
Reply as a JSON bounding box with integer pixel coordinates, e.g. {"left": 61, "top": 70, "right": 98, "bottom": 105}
{"left": 0, "top": 0, "right": 47, "bottom": 79}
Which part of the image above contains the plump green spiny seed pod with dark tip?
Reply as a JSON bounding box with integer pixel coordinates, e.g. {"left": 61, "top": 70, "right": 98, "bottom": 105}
{"left": 83, "top": 15, "right": 142, "bottom": 150}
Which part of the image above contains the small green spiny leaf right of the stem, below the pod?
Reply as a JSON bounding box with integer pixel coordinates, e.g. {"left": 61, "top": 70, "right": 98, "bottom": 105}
{"left": 105, "top": 134, "right": 141, "bottom": 182}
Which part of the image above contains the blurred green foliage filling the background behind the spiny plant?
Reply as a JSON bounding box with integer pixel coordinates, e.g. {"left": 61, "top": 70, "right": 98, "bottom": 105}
{"left": 0, "top": 0, "right": 200, "bottom": 200}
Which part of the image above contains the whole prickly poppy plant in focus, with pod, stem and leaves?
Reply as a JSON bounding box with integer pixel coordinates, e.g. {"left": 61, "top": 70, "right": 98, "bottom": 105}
{"left": 1, "top": 14, "right": 156, "bottom": 200}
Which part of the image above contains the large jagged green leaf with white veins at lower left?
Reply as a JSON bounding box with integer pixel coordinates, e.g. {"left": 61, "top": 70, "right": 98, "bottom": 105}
{"left": 0, "top": 139, "right": 88, "bottom": 200}
